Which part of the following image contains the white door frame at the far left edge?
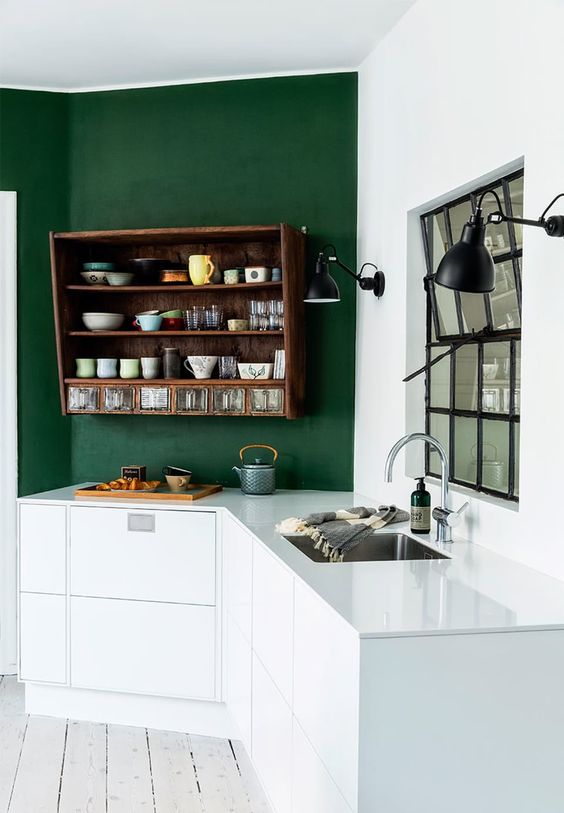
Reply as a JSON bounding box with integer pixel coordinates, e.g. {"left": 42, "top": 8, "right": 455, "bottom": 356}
{"left": 0, "top": 192, "right": 18, "bottom": 675}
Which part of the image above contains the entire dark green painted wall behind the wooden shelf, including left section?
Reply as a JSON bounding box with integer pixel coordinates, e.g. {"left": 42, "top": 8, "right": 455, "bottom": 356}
{"left": 0, "top": 73, "right": 357, "bottom": 493}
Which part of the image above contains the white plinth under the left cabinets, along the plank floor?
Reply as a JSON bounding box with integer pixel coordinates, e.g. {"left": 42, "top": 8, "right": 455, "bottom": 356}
{"left": 25, "top": 683, "right": 235, "bottom": 739}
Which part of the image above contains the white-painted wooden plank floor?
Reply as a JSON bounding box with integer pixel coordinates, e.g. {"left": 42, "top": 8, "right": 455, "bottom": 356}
{"left": 0, "top": 677, "right": 270, "bottom": 813}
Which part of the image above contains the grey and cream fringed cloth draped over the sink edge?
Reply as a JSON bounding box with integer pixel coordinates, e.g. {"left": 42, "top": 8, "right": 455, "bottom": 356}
{"left": 276, "top": 505, "right": 409, "bottom": 562}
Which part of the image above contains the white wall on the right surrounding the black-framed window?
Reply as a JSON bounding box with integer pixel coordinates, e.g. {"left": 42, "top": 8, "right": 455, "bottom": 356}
{"left": 355, "top": 0, "right": 564, "bottom": 579}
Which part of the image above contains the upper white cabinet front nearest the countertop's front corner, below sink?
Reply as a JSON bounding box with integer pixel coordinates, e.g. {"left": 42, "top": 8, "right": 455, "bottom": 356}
{"left": 293, "top": 580, "right": 360, "bottom": 809}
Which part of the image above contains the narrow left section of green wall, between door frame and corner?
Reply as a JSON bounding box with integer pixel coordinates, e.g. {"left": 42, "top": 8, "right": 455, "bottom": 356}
{"left": 0, "top": 90, "right": 71, "bottom": 494}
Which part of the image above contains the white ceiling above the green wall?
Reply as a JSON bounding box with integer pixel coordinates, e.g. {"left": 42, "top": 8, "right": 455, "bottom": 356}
{"left": 0, "top": 0, "right": 415, "bottom": 91}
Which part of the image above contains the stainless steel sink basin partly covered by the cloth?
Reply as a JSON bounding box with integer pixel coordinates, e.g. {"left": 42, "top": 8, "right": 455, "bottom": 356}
{"left": 285, "top": 534, "right": 450, "bottom": 564}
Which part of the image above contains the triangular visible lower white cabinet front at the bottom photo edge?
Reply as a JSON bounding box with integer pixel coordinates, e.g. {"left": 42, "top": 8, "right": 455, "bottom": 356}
{"left": 292, "top": 718, "right": 351, "bottom": 813}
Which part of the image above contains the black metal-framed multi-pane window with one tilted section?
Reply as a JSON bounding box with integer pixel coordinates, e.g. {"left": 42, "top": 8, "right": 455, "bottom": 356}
{"left": 421, "top": 170, "right": 524, "bottom": 501}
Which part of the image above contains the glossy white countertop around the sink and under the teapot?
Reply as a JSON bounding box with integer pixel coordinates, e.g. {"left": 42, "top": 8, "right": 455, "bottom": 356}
{"left": 20, "top": 486, "right": 564, "bottom": 638}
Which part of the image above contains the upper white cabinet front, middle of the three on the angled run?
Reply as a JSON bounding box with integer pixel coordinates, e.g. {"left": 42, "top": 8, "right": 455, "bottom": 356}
{"left": 253, "top": 542, "right": 294, "bottom": 705}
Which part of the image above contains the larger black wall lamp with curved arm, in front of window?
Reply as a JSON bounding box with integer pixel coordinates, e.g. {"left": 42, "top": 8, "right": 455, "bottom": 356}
{"left": 435, "top": 189, "right": 564, "bottom": 294}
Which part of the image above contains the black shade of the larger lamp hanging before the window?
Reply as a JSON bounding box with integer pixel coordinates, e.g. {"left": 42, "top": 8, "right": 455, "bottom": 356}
{"left": 435, "top": 213, "right": 495, "bottom": 294}
